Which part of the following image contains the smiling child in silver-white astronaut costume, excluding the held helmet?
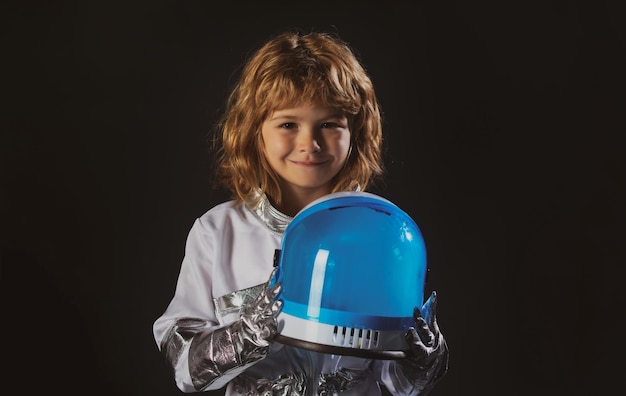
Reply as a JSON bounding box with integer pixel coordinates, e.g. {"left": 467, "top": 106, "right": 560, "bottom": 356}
{"left": 154, "top": 32, "right": 448, "bottom": 396}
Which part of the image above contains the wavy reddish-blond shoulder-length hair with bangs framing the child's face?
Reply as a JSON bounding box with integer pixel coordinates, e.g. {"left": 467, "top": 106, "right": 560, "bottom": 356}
{"left": 213, "top": 31, "right": 383, "bottom": 207}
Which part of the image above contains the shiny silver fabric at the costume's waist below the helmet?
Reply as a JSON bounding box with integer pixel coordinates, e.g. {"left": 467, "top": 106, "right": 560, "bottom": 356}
{"left": 233, "top": 368, "right": 369, "bottom": 396}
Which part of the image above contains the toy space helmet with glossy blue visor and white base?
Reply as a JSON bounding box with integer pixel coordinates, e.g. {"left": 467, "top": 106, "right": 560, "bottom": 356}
{"left": 270, "top": 192, "right": 427, "bottom": 359}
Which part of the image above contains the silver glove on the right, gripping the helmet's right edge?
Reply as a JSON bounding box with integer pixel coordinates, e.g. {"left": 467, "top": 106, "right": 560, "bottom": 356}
{"left": 397, "top": 291, "right": 449, "bottom": 395}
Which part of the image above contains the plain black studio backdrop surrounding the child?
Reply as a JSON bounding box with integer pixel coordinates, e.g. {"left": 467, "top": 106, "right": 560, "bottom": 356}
{"left": 0, "top": 0, "right": 626, "bottom": 395}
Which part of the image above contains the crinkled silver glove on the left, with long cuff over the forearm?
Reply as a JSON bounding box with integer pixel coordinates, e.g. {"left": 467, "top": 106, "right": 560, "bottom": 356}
{"left": 189, "top": 278, "right": 282, "bottom": 390}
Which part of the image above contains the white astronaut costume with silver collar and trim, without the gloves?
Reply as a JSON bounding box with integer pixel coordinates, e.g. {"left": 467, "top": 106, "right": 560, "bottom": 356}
{"left": 153, "top": 197, "right": 432, "bottom": 396}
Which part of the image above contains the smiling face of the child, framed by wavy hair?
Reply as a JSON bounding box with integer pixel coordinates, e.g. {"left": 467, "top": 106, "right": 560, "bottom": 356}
{"left": 261, "top": 105, "right": 350, "bottom": 199}
